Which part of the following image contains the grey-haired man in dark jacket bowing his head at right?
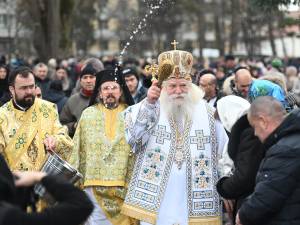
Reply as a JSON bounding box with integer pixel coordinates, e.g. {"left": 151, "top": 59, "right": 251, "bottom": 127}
{"left": 236, "top": 96, "right": 300, "bottom": 225}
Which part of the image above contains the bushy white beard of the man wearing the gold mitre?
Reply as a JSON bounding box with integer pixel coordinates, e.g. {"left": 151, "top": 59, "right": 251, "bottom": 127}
{"left": 160, "top": 85, "right": 203, "bottom": 121}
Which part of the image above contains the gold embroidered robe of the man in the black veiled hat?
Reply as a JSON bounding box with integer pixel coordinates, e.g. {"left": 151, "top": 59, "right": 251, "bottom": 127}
{"left": 69, "top": 104, "right": 135, "bottom": 225}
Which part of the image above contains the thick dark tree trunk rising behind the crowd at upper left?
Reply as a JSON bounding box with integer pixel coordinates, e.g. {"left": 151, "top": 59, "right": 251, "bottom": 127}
{"left": 18, "top": 0, "right": 76, "bottom": 62}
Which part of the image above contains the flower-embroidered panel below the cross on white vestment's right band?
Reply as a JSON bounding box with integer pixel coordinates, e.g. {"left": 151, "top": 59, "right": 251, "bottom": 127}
{"left": 193, "top": 154, "right": 211, "bottom": 189}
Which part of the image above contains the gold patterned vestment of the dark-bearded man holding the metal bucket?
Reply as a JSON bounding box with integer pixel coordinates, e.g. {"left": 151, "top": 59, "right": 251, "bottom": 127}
{"left": 0, "top": 99, "right": 73, "bottom": 171}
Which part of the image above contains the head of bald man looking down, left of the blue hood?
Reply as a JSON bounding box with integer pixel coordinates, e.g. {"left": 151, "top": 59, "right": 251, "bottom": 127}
{"left": 234, "top": 67, "right": 253, "bottom": 99}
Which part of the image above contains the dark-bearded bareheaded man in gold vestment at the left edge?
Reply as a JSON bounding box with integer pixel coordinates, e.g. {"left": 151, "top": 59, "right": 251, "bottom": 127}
{"left": 0, "top": 67, "right": 73, "bottom": 171}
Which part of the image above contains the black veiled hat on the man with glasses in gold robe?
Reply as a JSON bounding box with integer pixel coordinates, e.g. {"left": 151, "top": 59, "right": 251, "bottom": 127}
{"left": 89, "top": 67, "right": 134, "bottom": 106}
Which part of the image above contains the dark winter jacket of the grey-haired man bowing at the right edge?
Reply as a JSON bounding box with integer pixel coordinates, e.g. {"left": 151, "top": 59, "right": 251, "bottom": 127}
{"left": 239, "top": 109, "right": 300, "bottom": 225}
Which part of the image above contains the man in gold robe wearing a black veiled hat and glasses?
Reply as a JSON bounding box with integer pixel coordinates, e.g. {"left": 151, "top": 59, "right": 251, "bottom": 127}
{"left": 69, "top": 70, "right": 135, "bottom": 225}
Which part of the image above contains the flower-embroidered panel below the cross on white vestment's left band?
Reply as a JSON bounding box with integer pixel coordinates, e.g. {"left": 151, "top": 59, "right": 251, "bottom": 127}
{"left": 142, "top": 147, "right": 167, "bottom": 182}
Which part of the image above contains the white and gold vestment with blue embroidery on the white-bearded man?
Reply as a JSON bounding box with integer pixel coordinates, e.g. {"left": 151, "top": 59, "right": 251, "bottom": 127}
{"left": 122, "top": 100, "right": 228, "bottom": 225}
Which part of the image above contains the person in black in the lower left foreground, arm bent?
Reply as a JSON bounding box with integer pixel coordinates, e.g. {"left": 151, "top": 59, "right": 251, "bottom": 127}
{"left": 0, "top": 154, "right": 93, "bottom": 225}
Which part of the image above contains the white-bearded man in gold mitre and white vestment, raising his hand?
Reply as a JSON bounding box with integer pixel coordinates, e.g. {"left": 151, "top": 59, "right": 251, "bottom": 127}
{"left": 122, "top": 43, "right": 228, "bottom": 225}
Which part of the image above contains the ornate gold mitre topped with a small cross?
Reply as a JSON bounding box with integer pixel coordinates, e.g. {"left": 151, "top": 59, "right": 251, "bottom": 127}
{"left": 158, "top": 40, "right": 193, "bottom": 84}
